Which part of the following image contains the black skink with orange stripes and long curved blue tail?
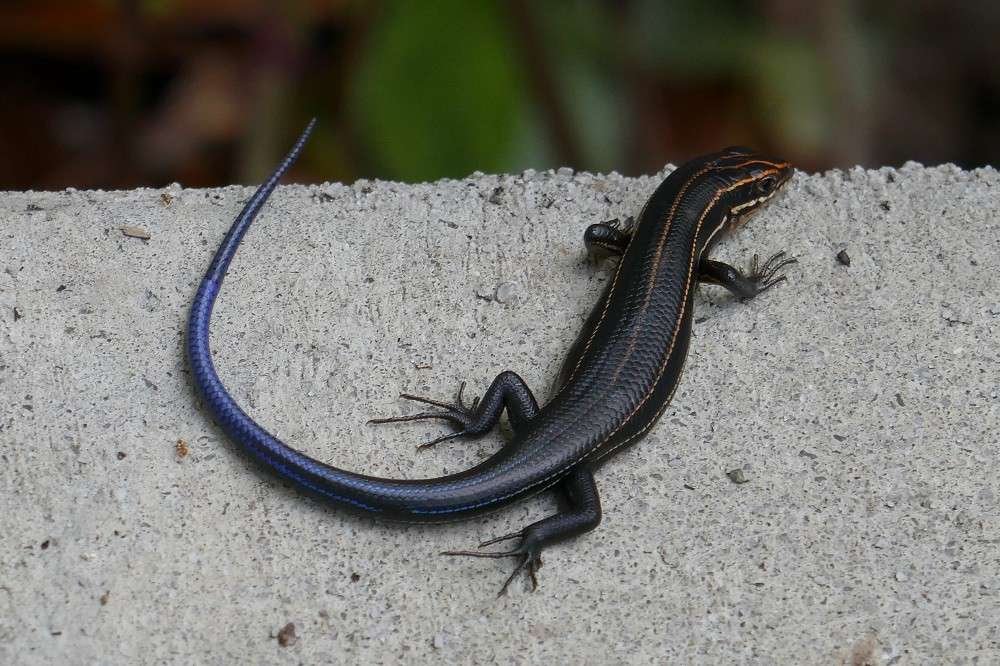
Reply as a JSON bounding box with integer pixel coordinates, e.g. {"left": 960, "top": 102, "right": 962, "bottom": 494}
{"left": 187, "top": 120, "right": 794, "bottom": 594}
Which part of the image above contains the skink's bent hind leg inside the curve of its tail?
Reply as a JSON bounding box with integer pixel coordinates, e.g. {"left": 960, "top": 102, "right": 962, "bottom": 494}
{"left": 368, "top": 370, "right": 538, "bottom": 449}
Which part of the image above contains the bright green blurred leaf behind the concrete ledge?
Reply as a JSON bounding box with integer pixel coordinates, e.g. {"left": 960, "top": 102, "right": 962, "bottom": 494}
{"left": 351, "top": 0, "right": 527, "bottom": 181}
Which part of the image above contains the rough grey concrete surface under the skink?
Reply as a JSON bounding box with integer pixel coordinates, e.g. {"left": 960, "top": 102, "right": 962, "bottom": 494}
{"left": 0, "top": 164, "right": 1000, "bottom": 664}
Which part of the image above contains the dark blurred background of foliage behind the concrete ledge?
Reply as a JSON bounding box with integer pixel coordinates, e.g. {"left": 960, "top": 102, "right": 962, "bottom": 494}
{"left": 0, "top": 0, "right": 1000, "bottom": 189}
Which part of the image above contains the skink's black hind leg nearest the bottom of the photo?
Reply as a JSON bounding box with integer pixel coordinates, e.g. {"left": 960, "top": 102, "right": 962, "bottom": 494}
{"left": 441, "top": 465, "right": 601, "bottom": 596}
